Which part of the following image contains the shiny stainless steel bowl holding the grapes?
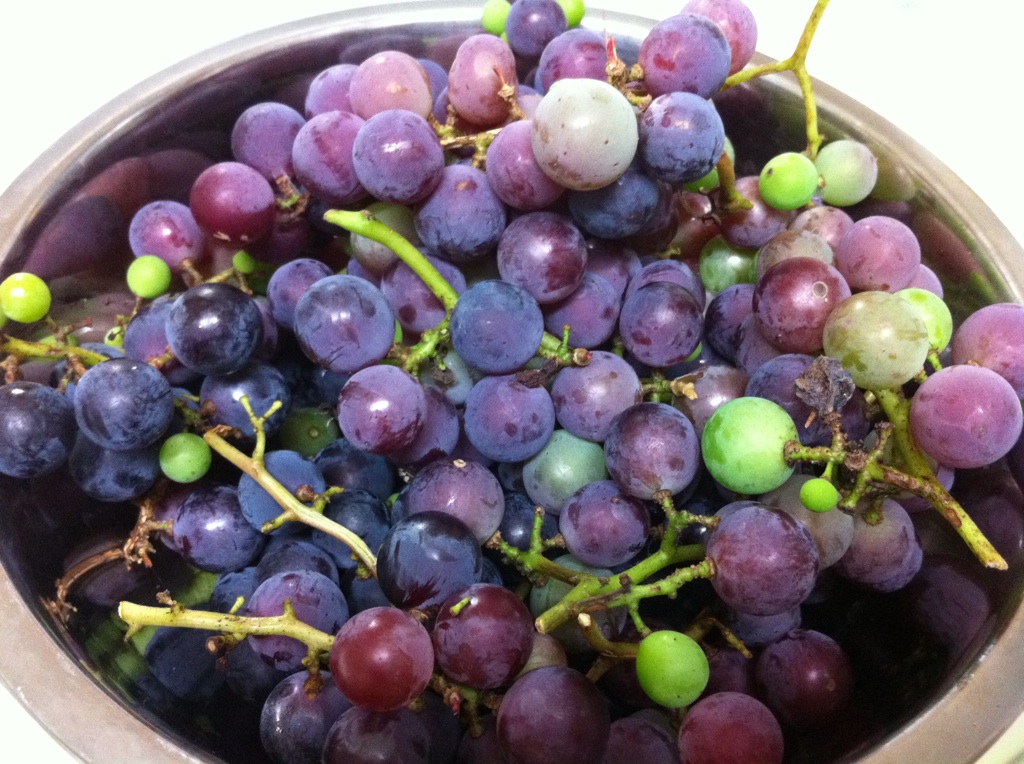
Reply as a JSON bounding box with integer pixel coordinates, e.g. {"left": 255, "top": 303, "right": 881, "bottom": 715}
{"left": 0, "top": 1, "right": 1024, "bottom": 764}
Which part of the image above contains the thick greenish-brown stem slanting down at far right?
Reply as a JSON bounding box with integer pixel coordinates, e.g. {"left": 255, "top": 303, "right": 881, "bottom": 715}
{"left": 873, "top": 390, "right": 1007, "bottom": 570}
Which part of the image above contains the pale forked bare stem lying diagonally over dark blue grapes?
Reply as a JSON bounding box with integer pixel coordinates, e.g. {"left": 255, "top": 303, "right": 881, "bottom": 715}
{"left": 203, "top": 397, "right": 377, "bottom": 577}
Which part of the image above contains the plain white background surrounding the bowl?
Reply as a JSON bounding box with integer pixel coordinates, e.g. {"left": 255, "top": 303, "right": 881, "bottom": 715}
{"left": 0, "top": 0, "right": 1024, "bottom": 764}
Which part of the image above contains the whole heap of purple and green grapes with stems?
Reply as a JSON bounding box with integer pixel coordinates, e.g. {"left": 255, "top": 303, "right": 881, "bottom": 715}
{"left": 0, "top": 0, "right": 1024, "bottom": 764}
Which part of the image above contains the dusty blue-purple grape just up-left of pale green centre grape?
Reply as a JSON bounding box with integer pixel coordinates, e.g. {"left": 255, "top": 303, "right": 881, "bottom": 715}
{"left": 463, "top": 375, "right": 555, "bottom": 462}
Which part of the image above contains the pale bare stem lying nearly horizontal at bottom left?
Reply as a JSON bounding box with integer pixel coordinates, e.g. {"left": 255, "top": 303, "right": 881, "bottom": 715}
{"left": 118, "top": 599, "right": 334, "bottom": 653}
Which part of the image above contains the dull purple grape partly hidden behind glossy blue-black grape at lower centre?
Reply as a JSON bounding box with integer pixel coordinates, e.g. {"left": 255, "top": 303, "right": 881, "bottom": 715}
{"left": 404, "top": 459, "right": 505, "bottom": 544}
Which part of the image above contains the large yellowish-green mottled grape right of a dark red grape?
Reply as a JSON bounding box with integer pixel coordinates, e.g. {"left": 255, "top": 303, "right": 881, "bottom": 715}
{"left": 822, "top": 292, "right": 930, "bottom": 390}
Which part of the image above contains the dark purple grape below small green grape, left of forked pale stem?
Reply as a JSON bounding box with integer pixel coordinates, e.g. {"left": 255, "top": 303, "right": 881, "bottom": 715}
{"left": 172, "top": 485, "right": 263, "bottom": 572}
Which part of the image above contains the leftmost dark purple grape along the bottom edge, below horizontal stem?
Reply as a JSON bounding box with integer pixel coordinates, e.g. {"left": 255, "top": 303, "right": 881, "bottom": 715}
{"left": 259, "top": 671, "right": 352, "bottom": 764}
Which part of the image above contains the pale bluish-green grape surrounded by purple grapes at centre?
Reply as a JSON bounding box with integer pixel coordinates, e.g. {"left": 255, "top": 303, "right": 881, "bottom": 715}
{"left": 522, "top": 430, "right": 608, "bottom": 511}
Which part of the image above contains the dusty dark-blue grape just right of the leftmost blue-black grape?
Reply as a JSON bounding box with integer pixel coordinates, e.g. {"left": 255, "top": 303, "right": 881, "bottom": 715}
{"left": 74, "top": 358, "right": 174, "bottom": 451}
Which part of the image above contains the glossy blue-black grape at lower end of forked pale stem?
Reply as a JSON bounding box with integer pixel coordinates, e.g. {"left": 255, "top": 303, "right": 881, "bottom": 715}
{"left": 377, "top": 511, "right": 483, "bottom": 613}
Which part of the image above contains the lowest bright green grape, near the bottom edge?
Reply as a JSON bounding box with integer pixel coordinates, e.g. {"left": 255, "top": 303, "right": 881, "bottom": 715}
{"left": 637, "top": 631, "right": 711, "bottom": 709}
